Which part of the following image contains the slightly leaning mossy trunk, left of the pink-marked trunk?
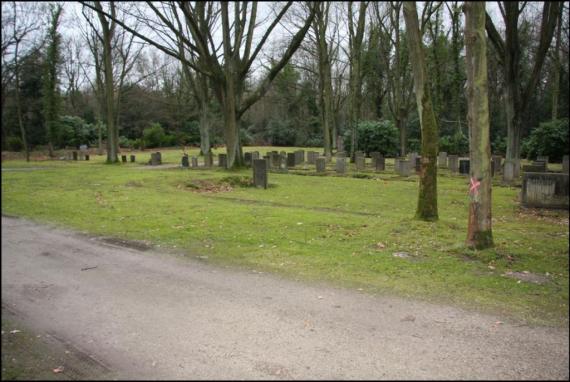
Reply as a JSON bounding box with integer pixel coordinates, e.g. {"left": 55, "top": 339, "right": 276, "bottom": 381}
{"left": 404, "top": 1, "right": 438, "bottom": 221}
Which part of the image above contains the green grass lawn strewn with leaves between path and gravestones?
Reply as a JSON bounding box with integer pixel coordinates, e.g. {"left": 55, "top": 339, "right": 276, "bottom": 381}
{"left": 2, "top": 147, "right": 569, "bottom": 326}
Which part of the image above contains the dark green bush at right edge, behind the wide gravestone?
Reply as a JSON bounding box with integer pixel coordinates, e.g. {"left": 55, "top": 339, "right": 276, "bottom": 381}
{"left": 521, "top": 118, "right": 570, "bottom": 161}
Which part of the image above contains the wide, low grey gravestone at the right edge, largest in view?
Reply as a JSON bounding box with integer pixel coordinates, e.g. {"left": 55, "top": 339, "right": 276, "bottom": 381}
{"left": 521, "top": 172, "right": 568, "bottom": 209}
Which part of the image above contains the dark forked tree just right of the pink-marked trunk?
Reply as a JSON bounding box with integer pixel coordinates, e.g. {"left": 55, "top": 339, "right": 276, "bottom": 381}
{"left": 485, "top": 1, "right": 561, "bottom": 182}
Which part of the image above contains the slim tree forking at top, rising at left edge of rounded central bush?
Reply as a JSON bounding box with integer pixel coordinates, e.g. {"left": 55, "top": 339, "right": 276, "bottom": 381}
{"left": 348, "top": 1, "right": 368, "bottom": 161}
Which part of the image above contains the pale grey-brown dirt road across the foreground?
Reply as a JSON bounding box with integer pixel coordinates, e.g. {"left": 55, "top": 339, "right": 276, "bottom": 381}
{"left": 2, "top": 217, "right": 569, "bottom": 379}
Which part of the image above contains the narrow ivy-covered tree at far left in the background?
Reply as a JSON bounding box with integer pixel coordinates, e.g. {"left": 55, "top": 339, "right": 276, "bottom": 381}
{"left": 43, "top": 5, "right": 63, "bottom": 157}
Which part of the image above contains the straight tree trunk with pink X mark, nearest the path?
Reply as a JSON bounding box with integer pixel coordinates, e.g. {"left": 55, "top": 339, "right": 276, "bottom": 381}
{"left": 464, "top": 1, "right": 493, "bottom": 249}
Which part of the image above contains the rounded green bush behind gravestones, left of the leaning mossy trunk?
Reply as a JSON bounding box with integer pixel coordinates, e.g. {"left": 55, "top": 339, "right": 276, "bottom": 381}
{"left": 344, "top": 120, "right": 400, "bottom": 156}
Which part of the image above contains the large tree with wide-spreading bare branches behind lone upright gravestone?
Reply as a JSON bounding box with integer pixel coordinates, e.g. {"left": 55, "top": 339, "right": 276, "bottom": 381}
{"left": 82, "top": 1, "right": 316, "bottom": 168}
